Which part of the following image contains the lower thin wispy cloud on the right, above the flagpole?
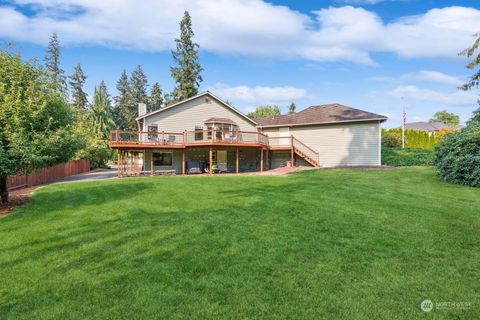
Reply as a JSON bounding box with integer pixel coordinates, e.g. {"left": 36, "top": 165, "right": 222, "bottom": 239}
{"left": 384, "top": 85, "right": 478, "bottom": 106}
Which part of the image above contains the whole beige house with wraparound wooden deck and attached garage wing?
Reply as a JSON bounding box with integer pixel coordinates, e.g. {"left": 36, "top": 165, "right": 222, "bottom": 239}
{"left": 110, "top": 91, "right": 387, "bottom": 176}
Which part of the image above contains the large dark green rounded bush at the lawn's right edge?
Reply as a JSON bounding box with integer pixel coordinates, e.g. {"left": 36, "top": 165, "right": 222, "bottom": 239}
{"left": 434, "top": 122, "right": 480, "bottom": 187}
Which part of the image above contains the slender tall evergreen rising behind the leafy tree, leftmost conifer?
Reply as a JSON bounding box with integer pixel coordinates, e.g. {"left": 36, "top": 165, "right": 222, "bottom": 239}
{"left": 45, "top": 33, "right": 67, "bottom": 95}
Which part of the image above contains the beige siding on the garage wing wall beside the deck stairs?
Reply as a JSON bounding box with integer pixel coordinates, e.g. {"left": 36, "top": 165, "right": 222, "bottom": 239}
{"left": 263, "top": 121, "right": 380, "bottom": 167}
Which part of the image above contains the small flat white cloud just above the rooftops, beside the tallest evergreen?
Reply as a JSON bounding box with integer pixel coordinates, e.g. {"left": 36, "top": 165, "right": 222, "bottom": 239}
{"left": 208, "top": 83, "right": 307, "bottom": 106}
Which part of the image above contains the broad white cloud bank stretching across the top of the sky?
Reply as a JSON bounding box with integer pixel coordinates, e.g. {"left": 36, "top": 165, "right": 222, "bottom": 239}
{"left": 0, "top": 0, "right": 480, "bottom": 64}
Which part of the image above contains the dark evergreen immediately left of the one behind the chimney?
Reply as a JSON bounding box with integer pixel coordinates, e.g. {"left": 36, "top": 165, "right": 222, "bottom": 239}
{"left": 113, "top": 70, "right": 132, "bottom": 130}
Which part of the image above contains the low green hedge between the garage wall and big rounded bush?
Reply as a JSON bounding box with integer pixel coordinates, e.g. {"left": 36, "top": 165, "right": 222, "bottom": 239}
{"left": 382, "top": 148, "right": 433, "bottom": 167}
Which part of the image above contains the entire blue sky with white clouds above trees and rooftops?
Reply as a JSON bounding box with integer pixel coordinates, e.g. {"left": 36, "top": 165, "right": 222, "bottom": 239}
{"left": 0, "top": 0, "right": 480, "bottom": 127}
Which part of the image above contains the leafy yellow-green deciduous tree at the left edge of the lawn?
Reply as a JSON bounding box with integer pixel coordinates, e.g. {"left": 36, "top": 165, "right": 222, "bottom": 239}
{"left": 0, "top": 50, "right": 80, "bottom": 202}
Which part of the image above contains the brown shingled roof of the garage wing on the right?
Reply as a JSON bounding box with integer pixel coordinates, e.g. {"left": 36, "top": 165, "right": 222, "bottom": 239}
{"left": 257, "top": 103, "right": 388, "bottom": 127}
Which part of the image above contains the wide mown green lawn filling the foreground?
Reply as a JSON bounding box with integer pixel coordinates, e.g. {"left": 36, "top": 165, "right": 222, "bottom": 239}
{"left": 0, "top": 167, "right": 480, "bottom": 320}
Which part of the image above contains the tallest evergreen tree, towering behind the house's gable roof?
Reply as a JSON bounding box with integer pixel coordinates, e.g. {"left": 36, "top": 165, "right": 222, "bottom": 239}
{"left": 169, "top": 11, "right": 203, "bottom": 103}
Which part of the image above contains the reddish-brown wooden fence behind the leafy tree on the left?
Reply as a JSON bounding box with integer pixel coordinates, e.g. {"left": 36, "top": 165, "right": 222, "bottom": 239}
{"left": 7, "top": 160, "right": 90, "bottom": 189}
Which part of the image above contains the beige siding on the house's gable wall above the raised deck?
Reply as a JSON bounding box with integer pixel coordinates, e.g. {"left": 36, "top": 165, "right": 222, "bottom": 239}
{"left": 143, "top": 96, "right": 257, "bottom": 132}
